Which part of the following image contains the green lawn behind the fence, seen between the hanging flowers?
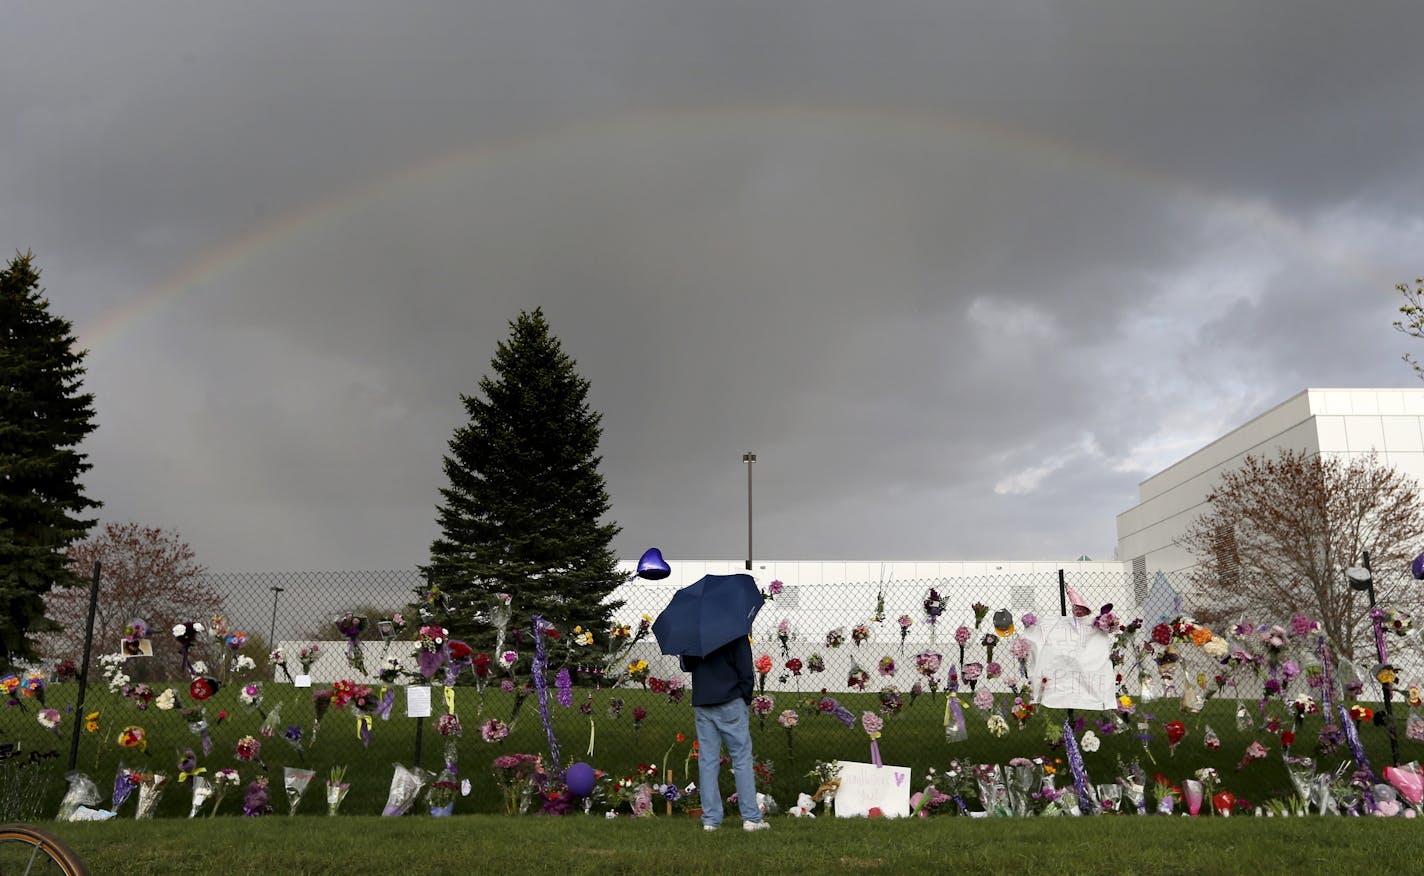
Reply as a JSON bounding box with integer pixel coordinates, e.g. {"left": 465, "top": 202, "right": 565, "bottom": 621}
{"left": 0, "top": 682, "right": 1424, "bottom": 830}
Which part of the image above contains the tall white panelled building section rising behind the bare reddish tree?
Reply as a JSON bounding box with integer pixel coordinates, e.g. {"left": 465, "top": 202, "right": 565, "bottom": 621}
{"left": 1118, "top": 387, "right": 1424, "bottom": 601}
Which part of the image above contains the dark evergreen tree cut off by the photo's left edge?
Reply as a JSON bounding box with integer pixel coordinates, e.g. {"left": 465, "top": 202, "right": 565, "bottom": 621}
{"left": 0, "top": 252, "right": 100, "bottom": 667}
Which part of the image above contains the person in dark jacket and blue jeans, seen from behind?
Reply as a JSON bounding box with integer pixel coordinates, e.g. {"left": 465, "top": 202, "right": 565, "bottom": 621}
{"left": 679, "top": 635, "right": 770, "bottom": 830}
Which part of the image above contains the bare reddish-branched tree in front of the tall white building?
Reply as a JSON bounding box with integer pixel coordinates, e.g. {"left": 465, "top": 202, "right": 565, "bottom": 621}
{"left": 1178, "top": 450, "right": 1424, "bottom": 658}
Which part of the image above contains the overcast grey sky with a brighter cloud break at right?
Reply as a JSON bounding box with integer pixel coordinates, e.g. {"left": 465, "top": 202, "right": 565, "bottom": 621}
{"left": 0, "top": 0, "right": 1424, "bottom": 571}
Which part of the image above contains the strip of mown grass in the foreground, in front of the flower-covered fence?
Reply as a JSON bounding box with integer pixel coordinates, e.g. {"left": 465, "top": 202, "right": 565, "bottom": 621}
{"left": 41, "top": 815, "right": 1424, "bottom": 876}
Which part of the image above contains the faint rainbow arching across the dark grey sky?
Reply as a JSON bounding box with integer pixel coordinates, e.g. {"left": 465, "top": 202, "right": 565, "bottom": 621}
{"left": 78, "top": 104, "right": 1394, "bottom": 350}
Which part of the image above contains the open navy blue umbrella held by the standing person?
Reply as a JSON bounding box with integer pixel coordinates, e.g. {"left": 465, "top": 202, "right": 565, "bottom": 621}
{"left": 652, "top": 574, "right": 766, "bottom": 657}
